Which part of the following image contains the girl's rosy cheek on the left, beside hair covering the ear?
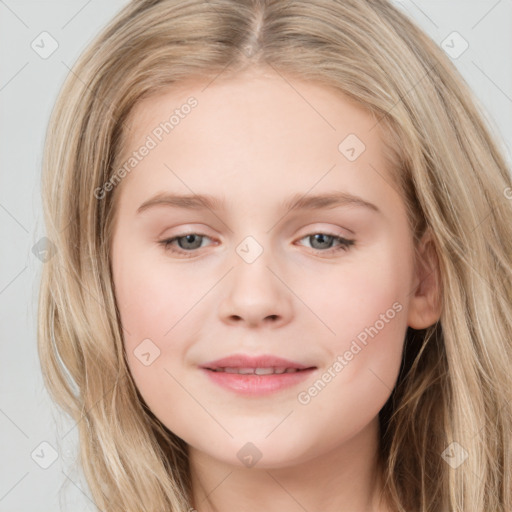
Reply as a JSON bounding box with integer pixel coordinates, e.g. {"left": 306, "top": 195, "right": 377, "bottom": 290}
{"left": 112, "top": 260, "right": 192, "bottom": 424}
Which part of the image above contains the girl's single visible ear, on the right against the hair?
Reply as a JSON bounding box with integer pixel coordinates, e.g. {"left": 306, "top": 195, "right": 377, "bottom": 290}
{"left": 407, "top": 228, "right": 441, "bottom": 329}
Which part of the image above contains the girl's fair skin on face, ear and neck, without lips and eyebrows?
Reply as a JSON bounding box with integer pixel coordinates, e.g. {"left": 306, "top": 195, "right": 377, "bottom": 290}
{"left": 111, "top": 68, "right": 440, "bottom": 512}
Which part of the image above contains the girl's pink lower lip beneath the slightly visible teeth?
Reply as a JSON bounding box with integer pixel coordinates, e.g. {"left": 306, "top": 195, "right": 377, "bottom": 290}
{"left": 202, "top": 368, "right": 315, "bottom": 395}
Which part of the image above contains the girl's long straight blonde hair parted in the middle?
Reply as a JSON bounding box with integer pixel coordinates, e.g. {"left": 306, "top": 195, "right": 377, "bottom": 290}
{"left": 38, "top": 0, "right": 512, "bottom": 512}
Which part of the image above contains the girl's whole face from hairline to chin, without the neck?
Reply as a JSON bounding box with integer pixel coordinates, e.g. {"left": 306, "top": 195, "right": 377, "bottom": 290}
{"left": 111, "top": 69, "right": 434, "bottom": 467}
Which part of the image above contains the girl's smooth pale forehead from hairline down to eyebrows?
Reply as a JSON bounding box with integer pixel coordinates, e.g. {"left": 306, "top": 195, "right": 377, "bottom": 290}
{"left": 114, "top": 70, "right": 397, "bottom": 218}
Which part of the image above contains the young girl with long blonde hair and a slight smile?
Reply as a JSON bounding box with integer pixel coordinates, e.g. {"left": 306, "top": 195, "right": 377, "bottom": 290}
{"left": 38, "top": 0, "right": 512, "bottom": 512}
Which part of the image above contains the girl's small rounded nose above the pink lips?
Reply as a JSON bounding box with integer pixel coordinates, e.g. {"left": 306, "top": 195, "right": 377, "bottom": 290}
{"left": 219, "top": 251, "right": 292, "bottom": 328}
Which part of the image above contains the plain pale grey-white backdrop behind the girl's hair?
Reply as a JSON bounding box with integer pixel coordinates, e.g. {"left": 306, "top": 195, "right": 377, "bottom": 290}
{"left": 0, "top": 0, "right": 512, "bottom": 512}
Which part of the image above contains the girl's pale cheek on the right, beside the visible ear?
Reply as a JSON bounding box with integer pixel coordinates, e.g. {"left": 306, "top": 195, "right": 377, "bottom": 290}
{"left": 301, "top": 241, "right": 412, "bottom": 406}
